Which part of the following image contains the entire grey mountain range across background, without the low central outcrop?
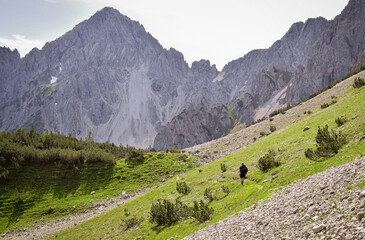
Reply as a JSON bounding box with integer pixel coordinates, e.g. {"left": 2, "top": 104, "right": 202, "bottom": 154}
{"left": 0, "top": 0, "right": 365, "bottom": 148}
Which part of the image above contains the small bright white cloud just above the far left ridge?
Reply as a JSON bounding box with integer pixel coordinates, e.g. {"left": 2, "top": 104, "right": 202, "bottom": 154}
{"left": 0, "top": 34, "right": 44, "bottom": 57}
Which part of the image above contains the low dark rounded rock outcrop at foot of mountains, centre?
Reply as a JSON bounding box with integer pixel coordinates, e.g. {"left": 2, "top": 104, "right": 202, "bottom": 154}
{"left": 153, "top": 103, "right": 234, "bottom": 150}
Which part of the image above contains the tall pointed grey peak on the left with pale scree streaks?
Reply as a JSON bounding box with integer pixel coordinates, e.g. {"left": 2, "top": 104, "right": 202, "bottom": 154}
{"left": 0, "top": 8, "right": 223, "bottom": 147}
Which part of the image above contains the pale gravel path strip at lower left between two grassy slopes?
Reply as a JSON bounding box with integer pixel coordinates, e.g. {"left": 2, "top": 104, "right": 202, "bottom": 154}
{"left": 0, "top": 188, "right": 153, "bottom": 240}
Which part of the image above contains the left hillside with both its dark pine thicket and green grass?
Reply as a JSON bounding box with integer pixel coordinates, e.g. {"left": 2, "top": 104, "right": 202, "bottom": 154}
{"left": 0, "top": 129, "right": 195, "bottom": 233}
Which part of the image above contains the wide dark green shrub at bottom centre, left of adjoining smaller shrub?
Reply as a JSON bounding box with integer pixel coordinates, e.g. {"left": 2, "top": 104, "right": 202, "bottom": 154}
{"left": 149, "top": 199, "right": 191, "bottom": 226}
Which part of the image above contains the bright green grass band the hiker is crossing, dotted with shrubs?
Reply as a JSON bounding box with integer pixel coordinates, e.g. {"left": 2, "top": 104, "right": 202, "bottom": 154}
{"left": 52, "top": 74, "right": 365, "bottom": 239}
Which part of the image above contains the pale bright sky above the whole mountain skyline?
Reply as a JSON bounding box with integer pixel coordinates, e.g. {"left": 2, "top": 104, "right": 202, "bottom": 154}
{"left": 0, "top": 0, "right": 348, "bottom": 69}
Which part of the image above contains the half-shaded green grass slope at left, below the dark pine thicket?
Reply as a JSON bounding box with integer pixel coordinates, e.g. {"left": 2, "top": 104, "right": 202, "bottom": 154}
{"left": 0, "top": 153, "right": 192, "bottom": 232}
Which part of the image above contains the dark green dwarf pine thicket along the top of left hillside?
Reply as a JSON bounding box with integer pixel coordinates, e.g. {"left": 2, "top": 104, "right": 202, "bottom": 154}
{"left": 0, "top": 127, "right": 145, "bottom": 169}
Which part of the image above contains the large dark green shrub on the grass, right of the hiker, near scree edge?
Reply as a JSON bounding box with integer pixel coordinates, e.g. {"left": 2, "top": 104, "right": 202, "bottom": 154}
{"left": 304, "top": 125, "right": 346, "bottom": 161}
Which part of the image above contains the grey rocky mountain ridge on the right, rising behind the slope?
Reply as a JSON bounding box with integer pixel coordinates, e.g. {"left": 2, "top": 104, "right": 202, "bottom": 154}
{"left": 155, "top": 0, "right": 365, "bottom": 148}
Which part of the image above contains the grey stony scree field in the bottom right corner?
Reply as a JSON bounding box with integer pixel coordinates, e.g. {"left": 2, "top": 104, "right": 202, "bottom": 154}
{"left": 184, "top": 157, "right": 365, "bottom": 240}
